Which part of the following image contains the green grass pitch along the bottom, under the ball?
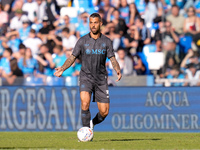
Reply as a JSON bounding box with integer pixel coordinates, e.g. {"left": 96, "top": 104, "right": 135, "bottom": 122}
{"left": 0, "top": 132, "right": 200, "bottom": 150}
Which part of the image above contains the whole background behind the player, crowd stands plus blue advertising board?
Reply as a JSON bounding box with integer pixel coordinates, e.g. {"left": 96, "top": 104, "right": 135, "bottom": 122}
{"left": 0, "top": 0, "right": 200, "bottom": 132}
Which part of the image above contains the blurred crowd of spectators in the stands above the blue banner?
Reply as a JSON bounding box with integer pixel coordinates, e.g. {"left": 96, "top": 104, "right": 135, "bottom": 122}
{"left": 0, "top": 0, "right": 200, "bottom": 86}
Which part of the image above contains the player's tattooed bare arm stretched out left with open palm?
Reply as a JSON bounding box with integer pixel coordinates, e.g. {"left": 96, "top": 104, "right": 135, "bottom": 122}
{"left": 54, "top": 55, "right": 76, "bottom": 77}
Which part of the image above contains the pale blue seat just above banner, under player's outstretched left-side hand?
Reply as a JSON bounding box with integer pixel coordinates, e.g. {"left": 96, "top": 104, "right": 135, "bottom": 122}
{"left": 46, "top": 76, "right": 65, "bottom": 86}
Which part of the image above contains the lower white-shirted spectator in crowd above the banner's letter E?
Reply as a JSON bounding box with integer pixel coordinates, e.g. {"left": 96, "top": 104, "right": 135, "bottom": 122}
{"left": 23, "top": 29, "right": 42, "bottom": 57}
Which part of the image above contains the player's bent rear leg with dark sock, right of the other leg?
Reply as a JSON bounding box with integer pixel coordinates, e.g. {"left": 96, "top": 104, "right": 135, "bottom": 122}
{"left": 90, "top": 102, "right": 110, "bottom": 126}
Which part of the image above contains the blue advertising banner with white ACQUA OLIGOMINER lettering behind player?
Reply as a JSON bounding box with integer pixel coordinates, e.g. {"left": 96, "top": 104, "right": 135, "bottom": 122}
{"left": 0, "top": 86, "right": 200, "bottom": 132}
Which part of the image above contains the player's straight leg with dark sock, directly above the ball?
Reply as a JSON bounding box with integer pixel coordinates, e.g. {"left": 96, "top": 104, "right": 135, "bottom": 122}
{"left": 80, "top": 91, "right": 91, "bottom": 127}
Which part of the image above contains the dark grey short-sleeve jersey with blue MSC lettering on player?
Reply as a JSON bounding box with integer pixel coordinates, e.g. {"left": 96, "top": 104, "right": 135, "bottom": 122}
{"left": 72, "top": 34, "right": 114, "bottom": 83}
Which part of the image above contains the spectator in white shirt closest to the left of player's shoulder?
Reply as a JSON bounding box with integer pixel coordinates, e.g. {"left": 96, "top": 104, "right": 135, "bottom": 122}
{"left": 62, "top": 27, "right": 77, "bottom": 50}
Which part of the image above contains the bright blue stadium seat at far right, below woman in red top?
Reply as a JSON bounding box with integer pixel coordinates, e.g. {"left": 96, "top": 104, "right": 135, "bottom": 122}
{"left": 179, "top": 36, "right": 192, "bottom": 54}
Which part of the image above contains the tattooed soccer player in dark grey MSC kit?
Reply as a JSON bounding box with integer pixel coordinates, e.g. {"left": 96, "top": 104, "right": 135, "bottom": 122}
{"left": 54, "top": 13, "right": 122, "bottom": 130}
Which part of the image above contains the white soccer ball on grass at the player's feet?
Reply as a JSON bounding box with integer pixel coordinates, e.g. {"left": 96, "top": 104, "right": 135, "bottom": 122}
{"left": 77, "top": 127, "right": 93, "bottom": 142}
